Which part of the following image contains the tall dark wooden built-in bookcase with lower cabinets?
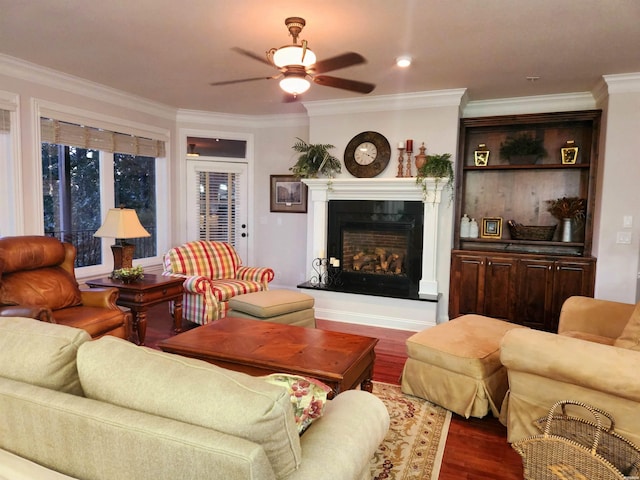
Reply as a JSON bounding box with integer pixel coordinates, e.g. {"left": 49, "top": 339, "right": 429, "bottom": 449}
{"left": 449, "top": 110, "right": 600, "bottom": 331}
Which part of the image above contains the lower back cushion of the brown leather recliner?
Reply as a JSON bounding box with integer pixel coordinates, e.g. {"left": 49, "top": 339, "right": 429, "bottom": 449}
{"left": 0, "top": 267, "right": 82, "bottom": 310}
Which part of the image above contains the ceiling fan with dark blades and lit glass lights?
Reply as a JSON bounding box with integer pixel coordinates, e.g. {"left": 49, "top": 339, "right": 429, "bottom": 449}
{"left": 211, "top": 17, "right": 376, "bottom": 99}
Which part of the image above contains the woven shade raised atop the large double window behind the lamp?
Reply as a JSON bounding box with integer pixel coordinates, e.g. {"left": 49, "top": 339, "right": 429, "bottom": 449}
{"left": 40, "top": 118, "right": 165, "bottom": 158}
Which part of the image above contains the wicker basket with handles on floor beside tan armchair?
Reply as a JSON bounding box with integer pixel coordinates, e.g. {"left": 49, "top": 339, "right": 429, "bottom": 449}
{"left": 512, "top": 400, "right": 640, "bottom": 480}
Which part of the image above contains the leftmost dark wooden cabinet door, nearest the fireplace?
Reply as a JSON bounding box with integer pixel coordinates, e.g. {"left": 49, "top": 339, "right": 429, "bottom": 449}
{"left": 449, "top": 253, "right": 485, "bottom": 318}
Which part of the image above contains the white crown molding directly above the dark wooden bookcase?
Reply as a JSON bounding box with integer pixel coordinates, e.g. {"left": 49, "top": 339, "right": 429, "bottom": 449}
{"left": 462, "top": 92, "right": 596, "bottom": 118}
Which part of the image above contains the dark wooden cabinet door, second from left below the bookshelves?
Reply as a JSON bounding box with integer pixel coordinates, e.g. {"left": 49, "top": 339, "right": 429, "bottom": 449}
{"left": 482, "top": 256, "right": 517, "bottom": 321}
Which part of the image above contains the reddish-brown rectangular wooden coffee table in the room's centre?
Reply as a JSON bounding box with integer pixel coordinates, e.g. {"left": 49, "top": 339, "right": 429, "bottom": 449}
{"left": 158, "top": 317, "right": 378, "bottom": 398}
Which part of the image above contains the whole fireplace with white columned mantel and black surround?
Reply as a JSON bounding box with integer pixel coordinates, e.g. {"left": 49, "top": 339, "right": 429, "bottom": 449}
{"left": 299, "top": 177, "right": 449, "bottom": 302}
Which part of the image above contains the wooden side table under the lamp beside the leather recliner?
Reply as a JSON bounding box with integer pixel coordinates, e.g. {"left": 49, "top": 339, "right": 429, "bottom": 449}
{"left": 86, "top": 273, "right": 184, "bottom": 345}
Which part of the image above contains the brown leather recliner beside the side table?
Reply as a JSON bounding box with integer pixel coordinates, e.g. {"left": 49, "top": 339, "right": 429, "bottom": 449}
{"left": 0, "top": 236, "right": 131, "bottom": 340}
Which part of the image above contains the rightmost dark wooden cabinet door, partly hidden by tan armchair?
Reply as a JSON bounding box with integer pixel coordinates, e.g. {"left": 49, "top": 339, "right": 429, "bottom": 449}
{"left": 552, "top": 258, "right": 596, "bottom": 331}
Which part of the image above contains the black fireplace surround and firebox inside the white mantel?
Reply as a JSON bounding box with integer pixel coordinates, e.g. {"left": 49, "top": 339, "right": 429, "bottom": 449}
{"left": 327, "top": 200, "right": 424, "bottom": 300}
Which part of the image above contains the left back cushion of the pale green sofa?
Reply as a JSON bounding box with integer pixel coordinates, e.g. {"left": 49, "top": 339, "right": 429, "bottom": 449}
{"left": 0, "top": 317, "right": 91, "bottom": 395}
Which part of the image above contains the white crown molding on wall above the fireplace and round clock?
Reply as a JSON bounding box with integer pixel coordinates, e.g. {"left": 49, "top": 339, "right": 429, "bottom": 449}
{"left": 302, "top": 88, "right": 466, "bottom": 117}
